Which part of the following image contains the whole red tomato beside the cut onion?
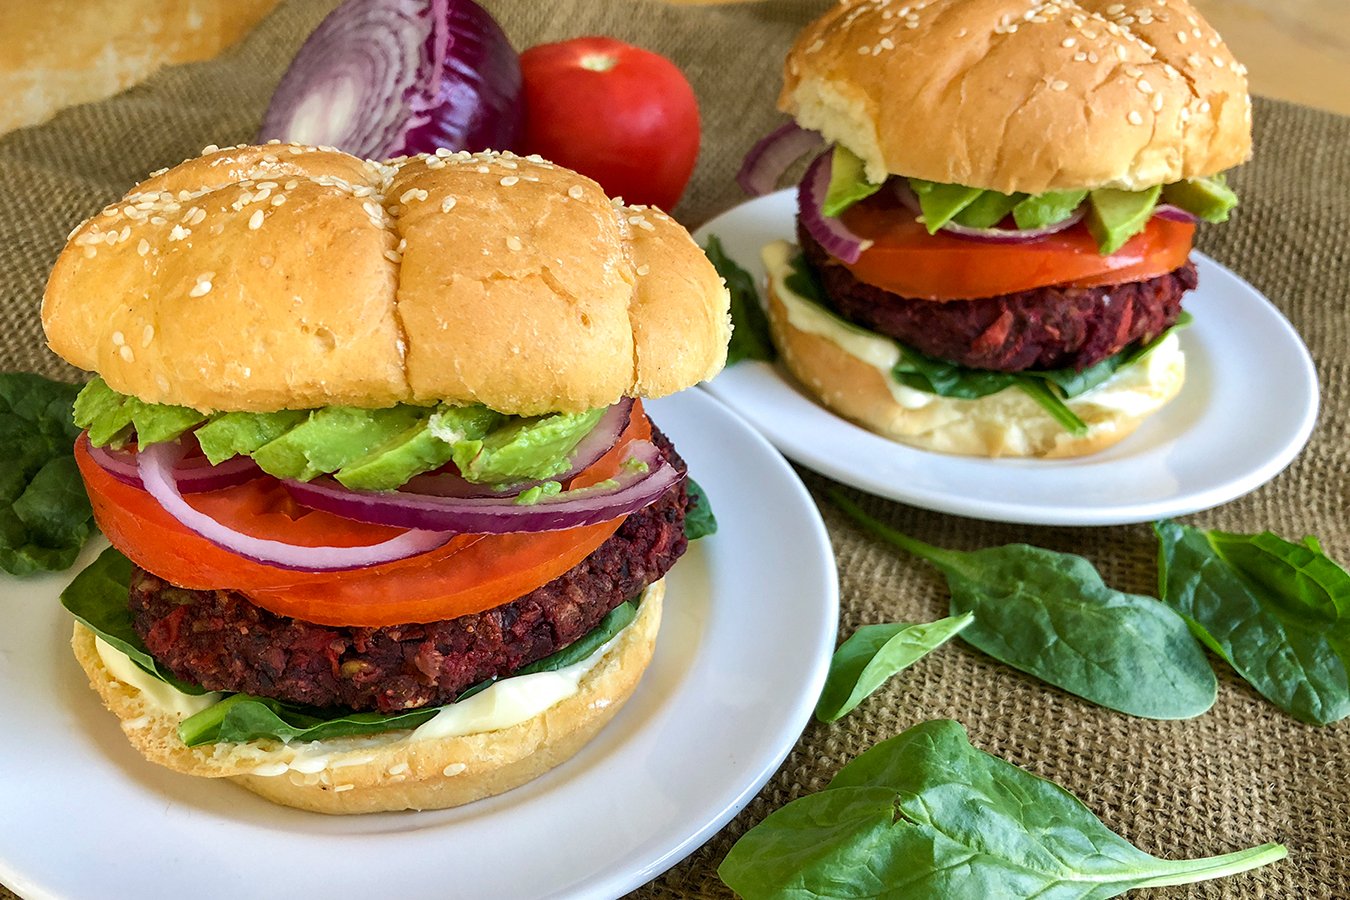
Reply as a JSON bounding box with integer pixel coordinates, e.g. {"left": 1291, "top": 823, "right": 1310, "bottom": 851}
{"left": 520, "top": 38, "right": 698, "bottom": 210}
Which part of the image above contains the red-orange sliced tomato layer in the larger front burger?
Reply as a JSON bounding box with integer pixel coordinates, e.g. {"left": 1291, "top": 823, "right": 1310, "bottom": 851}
{"left": 76, "top": 403, "right": 652, "bottom": 627}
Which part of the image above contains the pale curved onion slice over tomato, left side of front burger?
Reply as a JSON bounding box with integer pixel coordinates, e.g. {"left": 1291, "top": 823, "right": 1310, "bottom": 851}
{"left": 136, "top": 441, "right": 451, "bottom": 572}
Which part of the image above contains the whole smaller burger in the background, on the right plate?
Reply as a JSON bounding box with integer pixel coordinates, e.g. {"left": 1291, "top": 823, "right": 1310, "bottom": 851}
{"left": 743, "top": 0, "right": 1251, "bottom": 456}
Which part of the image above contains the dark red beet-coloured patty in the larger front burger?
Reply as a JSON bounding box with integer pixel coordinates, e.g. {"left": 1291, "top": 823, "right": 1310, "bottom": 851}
{"left": 131, "top": 429, "right": 689, "bottom": 712}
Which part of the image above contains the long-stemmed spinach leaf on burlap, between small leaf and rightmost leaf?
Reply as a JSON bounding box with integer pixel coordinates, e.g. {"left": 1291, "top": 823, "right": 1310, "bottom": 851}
{"left": 832, "top": 493, "right": 1219, "bottom": 719}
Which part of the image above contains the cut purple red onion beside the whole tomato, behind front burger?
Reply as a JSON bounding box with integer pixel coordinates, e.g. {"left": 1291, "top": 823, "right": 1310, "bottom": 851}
{"left": 258, "top": 0, "right": 524, "bottom": 159}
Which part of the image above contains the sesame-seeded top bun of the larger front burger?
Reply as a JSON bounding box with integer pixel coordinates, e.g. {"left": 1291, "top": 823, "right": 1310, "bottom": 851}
{"left": 42, "top": 144, "right": 730, "bottom": 416}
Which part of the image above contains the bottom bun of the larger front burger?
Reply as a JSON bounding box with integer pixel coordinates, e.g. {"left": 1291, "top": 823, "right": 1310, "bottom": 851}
{"left": 72, "top": 582, "right": 666, "bottom": 814}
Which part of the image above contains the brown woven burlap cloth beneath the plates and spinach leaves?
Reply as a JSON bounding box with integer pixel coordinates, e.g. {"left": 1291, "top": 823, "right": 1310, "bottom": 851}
{"left": 0, "top": 0, "right": 1350, "bottom": 897}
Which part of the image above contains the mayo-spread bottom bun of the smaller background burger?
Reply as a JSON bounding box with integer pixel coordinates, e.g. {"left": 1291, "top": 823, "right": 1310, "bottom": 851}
{"left": 764, "top": 243, "right": 1185, "bottom": 459}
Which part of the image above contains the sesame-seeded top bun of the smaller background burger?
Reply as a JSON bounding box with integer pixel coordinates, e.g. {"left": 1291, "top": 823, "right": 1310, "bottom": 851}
{"left": 779, "top": 0, "right": 1251, "bottom": 193}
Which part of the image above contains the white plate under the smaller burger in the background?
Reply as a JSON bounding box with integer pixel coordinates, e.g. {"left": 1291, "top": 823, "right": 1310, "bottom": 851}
{"left": 695, "top": 190, "right": 1318, "bottom": 525}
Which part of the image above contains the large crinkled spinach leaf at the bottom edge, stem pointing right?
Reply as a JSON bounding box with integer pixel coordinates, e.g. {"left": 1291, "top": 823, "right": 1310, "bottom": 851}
{"left": 717, "top": 719, "right": 1288, "bottom": 900}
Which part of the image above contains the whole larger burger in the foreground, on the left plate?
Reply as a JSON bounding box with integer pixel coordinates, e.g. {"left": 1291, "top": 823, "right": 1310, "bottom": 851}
{"left": 42, "top": 143, "right": 729, "bottom": 814}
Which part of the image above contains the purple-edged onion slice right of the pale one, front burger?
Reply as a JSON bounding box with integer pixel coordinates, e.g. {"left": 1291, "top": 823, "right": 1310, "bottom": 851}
{"left": 282, "top": 441, "right": 683, "bottom": 534}
